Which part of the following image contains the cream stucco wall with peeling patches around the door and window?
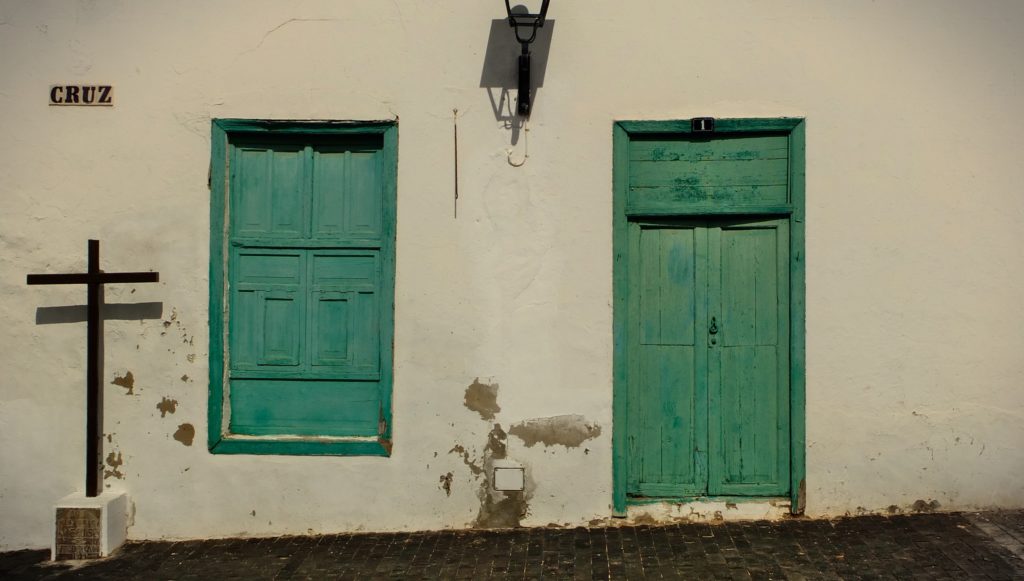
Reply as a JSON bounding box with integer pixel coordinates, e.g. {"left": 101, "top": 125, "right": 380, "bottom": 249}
{"left": 0, "top": 0, "right": 1024, "bottom": 549}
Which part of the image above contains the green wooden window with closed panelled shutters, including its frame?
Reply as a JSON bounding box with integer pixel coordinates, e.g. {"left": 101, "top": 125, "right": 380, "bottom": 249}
{"left": 208, "top": 119, "right": 397, "bottom": 456}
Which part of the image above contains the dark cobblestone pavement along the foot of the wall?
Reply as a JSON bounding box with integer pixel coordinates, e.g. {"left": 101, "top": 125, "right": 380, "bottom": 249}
{"left": 0, "top": 510, "right": 1024, "bottom": 580}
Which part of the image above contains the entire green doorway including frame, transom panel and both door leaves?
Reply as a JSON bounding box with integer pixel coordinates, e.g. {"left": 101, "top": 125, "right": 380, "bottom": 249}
{"left": 613, "top": 120, "right": 804, "bottom": 512}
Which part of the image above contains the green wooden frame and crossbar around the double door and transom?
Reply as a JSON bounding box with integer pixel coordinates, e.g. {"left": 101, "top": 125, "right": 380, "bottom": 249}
{"left": 611, "top": 118, "right": 806, "bottom": 516}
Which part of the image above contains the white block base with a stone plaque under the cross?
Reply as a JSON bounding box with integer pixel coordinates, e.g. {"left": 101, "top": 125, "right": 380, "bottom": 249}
{"left": 50, "top": 492, "right": 128, "bottom": 561}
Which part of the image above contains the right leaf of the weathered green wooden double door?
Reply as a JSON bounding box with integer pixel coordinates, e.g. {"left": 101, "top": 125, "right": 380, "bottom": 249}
{"left": 709, "top": 220, "right": 790, "bottom": 496}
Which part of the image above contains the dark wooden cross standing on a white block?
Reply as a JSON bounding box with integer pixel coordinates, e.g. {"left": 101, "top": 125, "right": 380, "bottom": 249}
{"left": 28, "top": 240, "right": 160, "bottom": 497}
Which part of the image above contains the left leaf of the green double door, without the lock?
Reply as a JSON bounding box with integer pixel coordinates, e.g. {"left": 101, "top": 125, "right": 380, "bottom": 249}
{"left": 628, "top": 223, "right": 707, "bottom": 496}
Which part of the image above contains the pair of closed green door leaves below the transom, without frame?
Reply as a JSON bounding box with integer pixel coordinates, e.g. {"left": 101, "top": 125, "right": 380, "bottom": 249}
{"left": 626, "top": 218, "right": 790, "bottom": 497}
